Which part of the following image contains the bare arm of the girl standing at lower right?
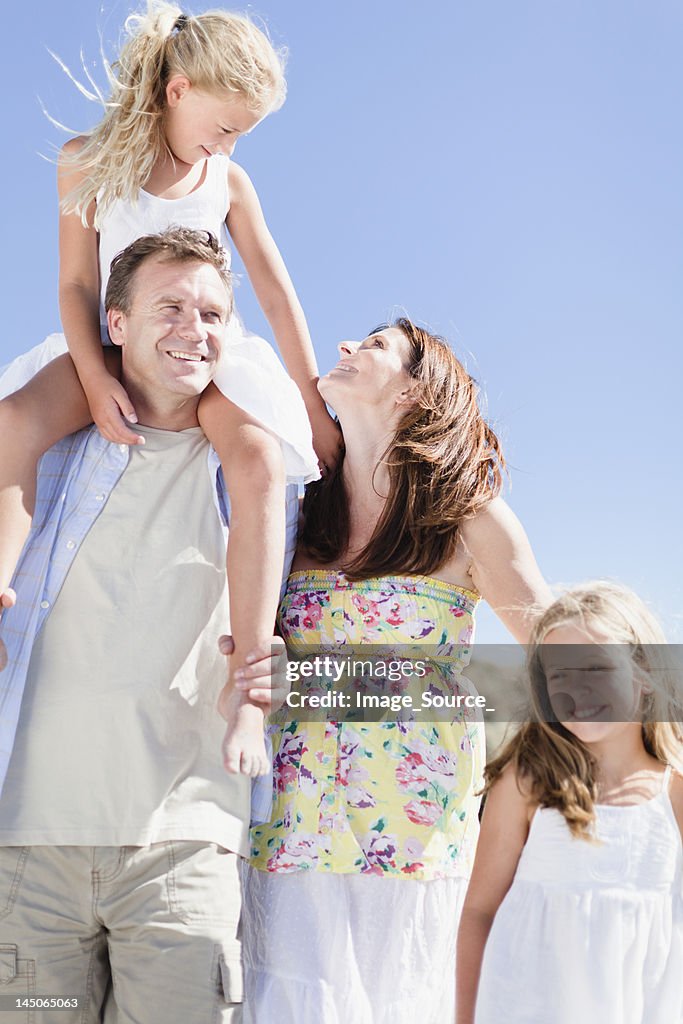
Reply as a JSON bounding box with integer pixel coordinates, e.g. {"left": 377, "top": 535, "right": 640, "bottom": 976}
{"left": 456, "top": 765, "right": 532, "bottom": 1024}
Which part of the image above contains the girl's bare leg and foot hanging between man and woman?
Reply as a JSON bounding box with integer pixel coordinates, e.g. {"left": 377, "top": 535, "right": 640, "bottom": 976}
{"left": 199, "top": 385, "right": 285, "bottom": 776}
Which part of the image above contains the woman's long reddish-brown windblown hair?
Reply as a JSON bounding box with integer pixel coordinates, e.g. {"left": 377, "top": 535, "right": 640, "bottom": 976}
{"left": 301, "top": 316, "right": 505, "bottom": 580}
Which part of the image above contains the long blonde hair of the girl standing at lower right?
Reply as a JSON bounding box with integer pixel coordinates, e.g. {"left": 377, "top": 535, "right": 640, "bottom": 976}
{"left": 484, "top": 580, "right": 683, "bottom": 839}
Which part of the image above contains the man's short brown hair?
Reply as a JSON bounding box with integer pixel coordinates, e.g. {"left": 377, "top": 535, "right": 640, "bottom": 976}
{"left": 104, "top": 227, "right": 232, "bottom": 314}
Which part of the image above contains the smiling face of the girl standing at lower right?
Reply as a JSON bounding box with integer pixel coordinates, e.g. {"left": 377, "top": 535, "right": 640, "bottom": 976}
{"left": 541, "top": 622, "right": 648, "bottom": 743}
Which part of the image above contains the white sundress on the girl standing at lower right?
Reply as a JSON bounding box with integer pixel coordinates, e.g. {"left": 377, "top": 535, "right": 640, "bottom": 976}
{"left": 475, "top": 768, "right": 683, "bottom": 1024}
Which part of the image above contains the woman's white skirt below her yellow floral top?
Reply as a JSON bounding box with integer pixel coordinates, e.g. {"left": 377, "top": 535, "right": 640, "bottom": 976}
{"left": 241, "top": 864, "right": 467, "bottom": 1024}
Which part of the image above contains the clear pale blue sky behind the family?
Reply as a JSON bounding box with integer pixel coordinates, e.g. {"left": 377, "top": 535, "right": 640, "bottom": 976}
{"left": 0, "top": 0, "right": 683, "bottom": 642}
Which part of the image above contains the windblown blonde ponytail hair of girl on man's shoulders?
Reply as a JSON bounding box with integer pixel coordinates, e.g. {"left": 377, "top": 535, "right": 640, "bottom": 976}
{"left": 57, "top": 0, "right": 286, "bottom": 226}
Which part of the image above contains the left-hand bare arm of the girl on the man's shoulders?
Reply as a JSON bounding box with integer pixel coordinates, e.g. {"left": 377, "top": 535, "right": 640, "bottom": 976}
{"left": 57, "top": 138, "right": 142, "bottom": 444}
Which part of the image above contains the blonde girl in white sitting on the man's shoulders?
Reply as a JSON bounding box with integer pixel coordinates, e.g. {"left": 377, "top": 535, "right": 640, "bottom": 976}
{"left": 0, "top": 0, "right": 339, "bottom": 775}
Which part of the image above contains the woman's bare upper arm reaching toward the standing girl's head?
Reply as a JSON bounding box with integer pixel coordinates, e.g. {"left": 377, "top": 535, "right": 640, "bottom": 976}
{"left": 461, "top": 498, "right": 552, "bottom": 643}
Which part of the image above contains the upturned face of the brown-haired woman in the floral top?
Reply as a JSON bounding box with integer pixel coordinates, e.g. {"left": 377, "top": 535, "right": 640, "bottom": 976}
{"left": 318, "top": 327, "right": 411, "bottom": 413}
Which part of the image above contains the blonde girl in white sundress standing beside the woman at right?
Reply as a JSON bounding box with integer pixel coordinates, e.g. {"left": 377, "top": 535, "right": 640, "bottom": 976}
{"left": 457, "top": 582, "right": 683, "bottom": 1024}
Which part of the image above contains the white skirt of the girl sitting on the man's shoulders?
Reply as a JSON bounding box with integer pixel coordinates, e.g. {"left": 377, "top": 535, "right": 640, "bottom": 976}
{"left": 0, "top": 315, "right": 319, "bottom": 483}
